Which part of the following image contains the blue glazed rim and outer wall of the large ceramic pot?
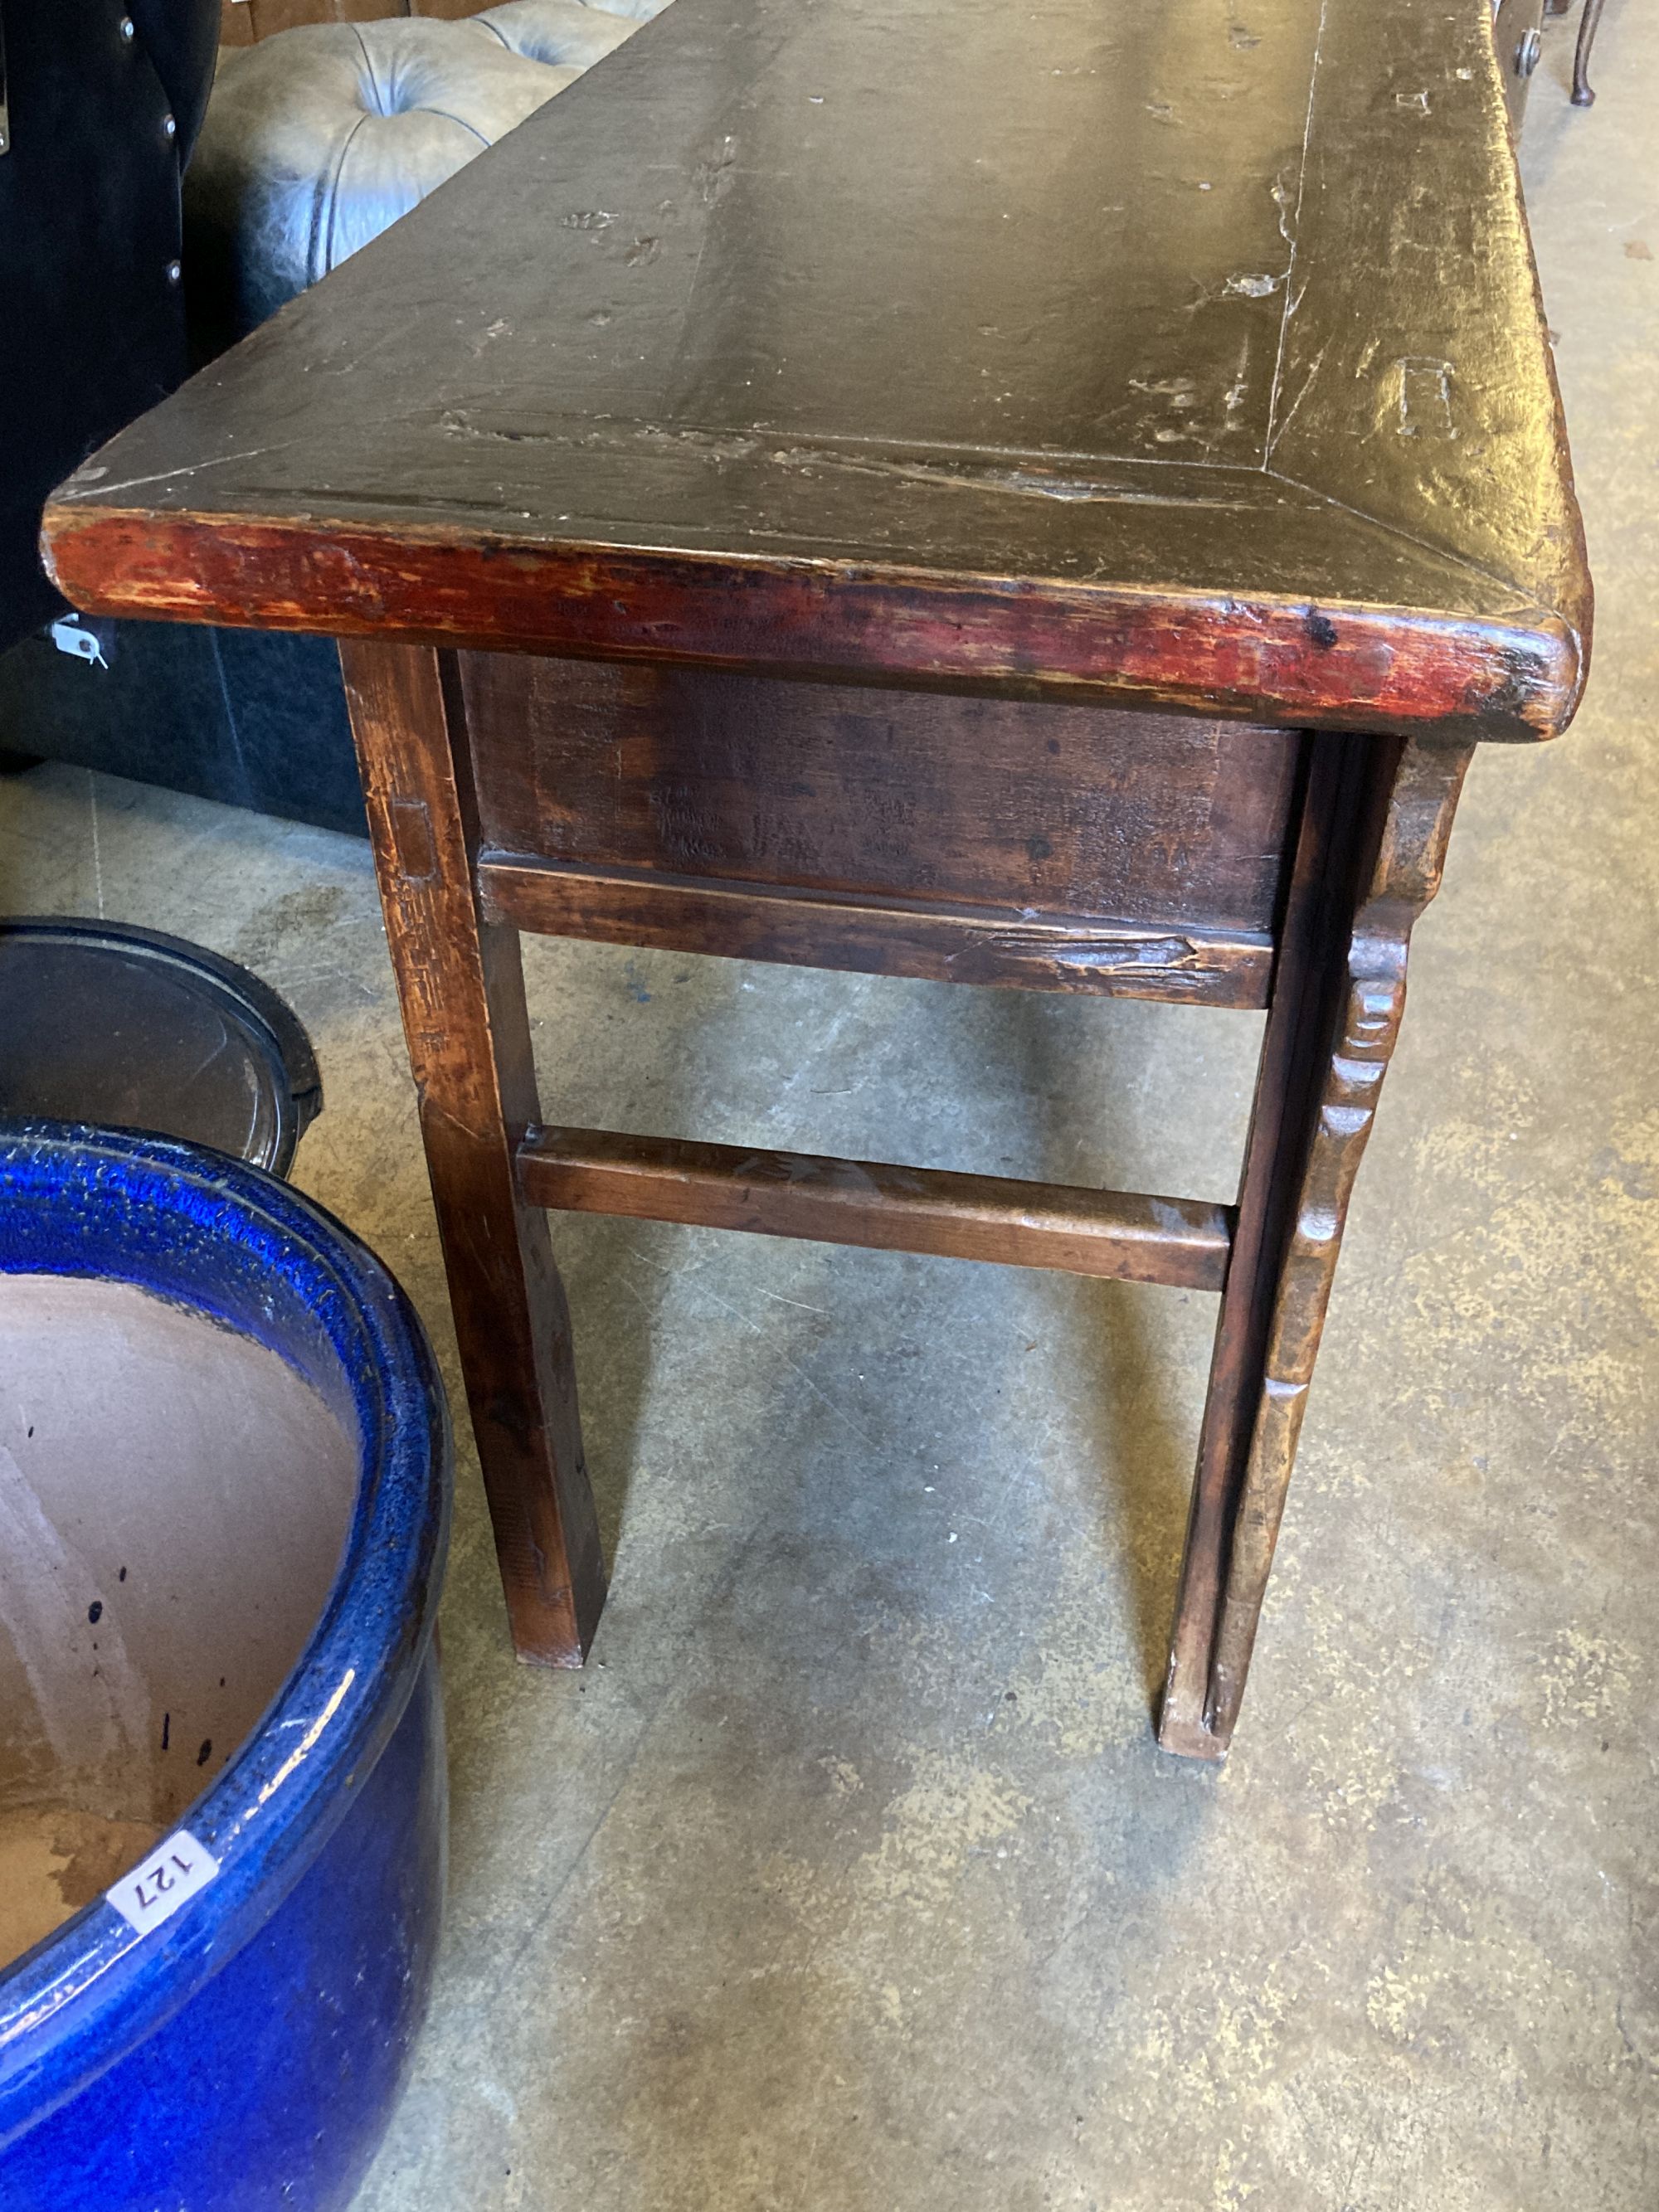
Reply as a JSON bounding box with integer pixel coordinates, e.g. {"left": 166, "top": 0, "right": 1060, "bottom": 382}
{"left": 0, "top": 1124, "right": 449, "bottom": 2212}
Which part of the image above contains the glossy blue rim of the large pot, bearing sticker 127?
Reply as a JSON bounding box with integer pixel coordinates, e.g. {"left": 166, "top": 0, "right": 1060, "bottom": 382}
{"left": 0, "top": 1121, "right": 449, "bottom": 2148}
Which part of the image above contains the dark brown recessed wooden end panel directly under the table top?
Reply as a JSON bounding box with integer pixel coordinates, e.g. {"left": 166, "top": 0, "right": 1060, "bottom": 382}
{"left": 462, "top": 653, "right": 1298, "bottom": 931}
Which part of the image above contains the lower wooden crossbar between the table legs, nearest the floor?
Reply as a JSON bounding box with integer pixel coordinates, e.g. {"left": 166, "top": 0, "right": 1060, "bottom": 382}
{"left": 518, "top": 1128, "right": 1232, "bottom": 1290}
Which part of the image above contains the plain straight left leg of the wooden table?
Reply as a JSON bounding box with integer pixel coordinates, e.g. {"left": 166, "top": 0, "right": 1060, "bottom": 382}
{"left": 341, "top": 639, "right": 604, "bottom": 1665}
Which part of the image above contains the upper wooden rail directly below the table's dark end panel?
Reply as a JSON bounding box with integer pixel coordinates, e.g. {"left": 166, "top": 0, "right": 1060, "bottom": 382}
{"left": 478, "top": 852, "right": 1272, "bottom": 1006}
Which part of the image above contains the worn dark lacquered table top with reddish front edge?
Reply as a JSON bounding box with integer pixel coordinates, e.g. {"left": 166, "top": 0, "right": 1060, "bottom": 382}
{"left": 46, "top": 0, "right": 1590, "bottom": 739}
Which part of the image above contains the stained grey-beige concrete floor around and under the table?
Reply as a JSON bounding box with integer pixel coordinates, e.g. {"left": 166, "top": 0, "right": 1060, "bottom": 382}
{"left": 0, "top": 22, "right": 1659, "bottom": 2212}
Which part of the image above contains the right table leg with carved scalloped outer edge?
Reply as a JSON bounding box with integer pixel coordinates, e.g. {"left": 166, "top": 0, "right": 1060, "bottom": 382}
{"left": 1159, "top": 737, "right": 1471, "bottom": 1758}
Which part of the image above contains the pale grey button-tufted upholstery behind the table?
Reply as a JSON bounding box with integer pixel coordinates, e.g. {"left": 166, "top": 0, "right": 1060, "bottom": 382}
{"left": 186, "top": 0, "right": 668, "bottom": 341}
